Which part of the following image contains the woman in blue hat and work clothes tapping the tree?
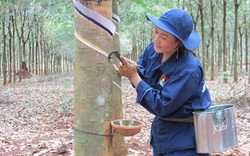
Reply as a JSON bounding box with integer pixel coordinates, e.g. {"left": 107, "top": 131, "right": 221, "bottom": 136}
{"left": 114, "top": 9, "right": 211, "bottom": 156}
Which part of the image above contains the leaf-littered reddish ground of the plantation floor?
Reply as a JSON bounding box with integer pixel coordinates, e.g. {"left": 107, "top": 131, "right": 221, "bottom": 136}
{"left": 0, "top": 74, "right": 250, "bottom": 156}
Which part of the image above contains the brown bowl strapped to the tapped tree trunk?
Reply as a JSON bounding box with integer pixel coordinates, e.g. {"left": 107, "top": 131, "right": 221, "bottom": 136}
{"left": 111, "top": 119, "right": 143, "bottom": 136}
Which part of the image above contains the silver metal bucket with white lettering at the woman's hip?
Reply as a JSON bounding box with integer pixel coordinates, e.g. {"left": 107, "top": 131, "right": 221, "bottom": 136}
{"left": 193, "top": 104, "right": 238, "bottom": 153}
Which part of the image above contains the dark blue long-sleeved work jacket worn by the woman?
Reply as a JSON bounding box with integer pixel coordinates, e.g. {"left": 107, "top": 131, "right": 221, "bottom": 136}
{"left": 136, "top": 42, "right": 211, "bottom": 153}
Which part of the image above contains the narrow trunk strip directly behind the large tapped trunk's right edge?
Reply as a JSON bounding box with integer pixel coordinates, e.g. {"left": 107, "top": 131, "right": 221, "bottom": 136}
{"left": 112, "top": 0, "right": 127, "bottom": 156}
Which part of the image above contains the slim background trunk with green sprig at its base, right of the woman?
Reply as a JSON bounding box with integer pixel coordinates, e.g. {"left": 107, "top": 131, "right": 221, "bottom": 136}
{"left": 223, "top": 0, "right": 227, "bottom": 83}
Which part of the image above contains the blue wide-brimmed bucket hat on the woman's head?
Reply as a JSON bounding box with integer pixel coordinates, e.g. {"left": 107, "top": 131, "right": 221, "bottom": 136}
{"left": 146, "top": 9, "right": 200, "bottom": 50}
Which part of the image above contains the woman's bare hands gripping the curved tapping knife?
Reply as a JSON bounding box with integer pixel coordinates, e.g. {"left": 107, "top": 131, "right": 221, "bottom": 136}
{"left": 113, "top": 56, "right": 141, "bottom": 87}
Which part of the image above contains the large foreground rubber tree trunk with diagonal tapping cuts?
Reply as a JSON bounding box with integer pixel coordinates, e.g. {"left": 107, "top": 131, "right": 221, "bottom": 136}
{"left": 73, "top": 0, "right": 126, "bottom": 156}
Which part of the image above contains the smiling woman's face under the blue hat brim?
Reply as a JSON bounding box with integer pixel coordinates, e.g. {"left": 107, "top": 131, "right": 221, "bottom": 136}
{"left": 153, "top": 27, "right": 181, "bottom": 54}
